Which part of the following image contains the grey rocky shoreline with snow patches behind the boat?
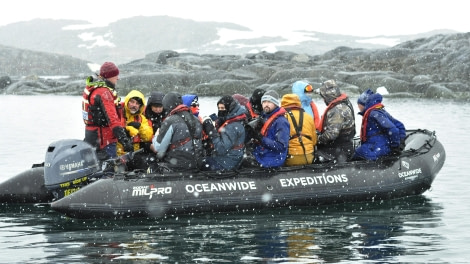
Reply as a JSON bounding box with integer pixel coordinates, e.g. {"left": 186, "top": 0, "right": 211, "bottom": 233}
{"left": 0, "top": 33, "right": 470, "bottom": 101}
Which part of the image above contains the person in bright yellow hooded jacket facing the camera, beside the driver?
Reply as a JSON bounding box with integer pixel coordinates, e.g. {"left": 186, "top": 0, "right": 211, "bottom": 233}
{"left": 117, "top": 90, "right": 153, "bottom": 169}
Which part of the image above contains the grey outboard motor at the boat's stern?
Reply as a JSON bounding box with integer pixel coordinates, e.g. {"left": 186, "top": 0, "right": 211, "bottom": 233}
{"left": 44, "top": 139, "right": 100, "bottom": 199}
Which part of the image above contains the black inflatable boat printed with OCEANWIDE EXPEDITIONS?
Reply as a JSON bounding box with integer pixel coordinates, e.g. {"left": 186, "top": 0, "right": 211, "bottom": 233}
{"left": 0, "top": 129, "right": 446, "bottom": 219}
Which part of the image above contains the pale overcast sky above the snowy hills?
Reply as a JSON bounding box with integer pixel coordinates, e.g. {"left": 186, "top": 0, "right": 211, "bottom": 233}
{"left": 0, "top": 0, "right": 470, "bottom": 37}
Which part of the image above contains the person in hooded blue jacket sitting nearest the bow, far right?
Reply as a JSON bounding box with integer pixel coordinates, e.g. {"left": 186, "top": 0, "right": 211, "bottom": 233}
{"left": 353, "top": 89, "right": 406, "bottom": 160}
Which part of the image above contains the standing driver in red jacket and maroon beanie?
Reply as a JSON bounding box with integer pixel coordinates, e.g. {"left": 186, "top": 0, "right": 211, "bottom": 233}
{"left": 82, "top": 62, "right": 134, "bottom": 161}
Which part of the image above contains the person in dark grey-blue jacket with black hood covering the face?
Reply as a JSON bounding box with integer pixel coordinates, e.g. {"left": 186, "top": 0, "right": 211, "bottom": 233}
{"left": 201, "top": 95, "right": 246, "bottom": 170}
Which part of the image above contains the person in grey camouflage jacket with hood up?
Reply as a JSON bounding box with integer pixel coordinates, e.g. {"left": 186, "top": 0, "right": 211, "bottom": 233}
{"left": 317, "top": 80, "right": 356, "bottom": 162}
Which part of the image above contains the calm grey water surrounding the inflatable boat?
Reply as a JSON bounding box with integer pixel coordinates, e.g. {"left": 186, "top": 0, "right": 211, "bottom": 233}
{"left": 0, "top": 96, "right": 470, "bottom": 263}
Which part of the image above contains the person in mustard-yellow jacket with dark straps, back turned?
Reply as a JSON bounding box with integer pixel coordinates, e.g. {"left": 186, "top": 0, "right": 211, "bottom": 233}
{"left": 281, "top": 94, "right": 317, "bottom": 166}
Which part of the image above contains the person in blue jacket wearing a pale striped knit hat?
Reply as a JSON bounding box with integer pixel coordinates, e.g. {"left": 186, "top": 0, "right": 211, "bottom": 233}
{"left": 244, "top": 90, "right": 290, "bottom": 168}
